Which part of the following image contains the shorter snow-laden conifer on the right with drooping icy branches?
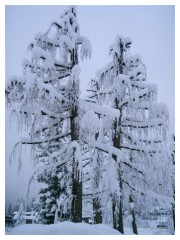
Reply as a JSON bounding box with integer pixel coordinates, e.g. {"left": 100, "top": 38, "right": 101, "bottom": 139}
{"left": 86, "top": 36, "right": 172, "bottom": 233}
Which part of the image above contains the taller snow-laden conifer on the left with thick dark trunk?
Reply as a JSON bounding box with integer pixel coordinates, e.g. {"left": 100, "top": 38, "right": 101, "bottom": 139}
{"left": 6, "top": 6, "right": 91, "bottom": 223}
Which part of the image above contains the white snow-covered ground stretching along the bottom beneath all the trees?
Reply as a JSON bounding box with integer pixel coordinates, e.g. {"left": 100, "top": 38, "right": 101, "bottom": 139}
{"left": 6, "top": 222, "right": 170, "bottom": 235}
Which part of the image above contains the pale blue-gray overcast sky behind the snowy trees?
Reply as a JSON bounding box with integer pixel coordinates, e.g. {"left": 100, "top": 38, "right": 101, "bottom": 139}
{"left": 6, "top": 6, "right": 175, "bottom": 202}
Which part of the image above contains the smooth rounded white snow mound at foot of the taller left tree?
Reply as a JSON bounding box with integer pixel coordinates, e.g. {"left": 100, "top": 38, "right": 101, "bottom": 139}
{"left": 9, "top": 222, "right": 120, "bottom": 235}
